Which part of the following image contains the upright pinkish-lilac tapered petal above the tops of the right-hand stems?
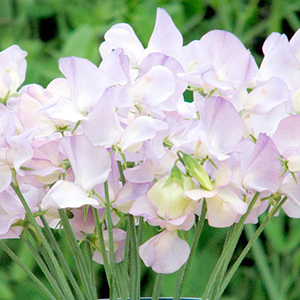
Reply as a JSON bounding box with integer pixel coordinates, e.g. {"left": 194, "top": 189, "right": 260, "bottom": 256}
{"left": 243, "top": 134, "right": 282, "bottom": 193}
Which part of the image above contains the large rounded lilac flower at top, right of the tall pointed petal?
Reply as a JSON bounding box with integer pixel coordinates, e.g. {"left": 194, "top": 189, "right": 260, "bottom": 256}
{"left": 180, "top": 30, "right": 257, "bottom": 95}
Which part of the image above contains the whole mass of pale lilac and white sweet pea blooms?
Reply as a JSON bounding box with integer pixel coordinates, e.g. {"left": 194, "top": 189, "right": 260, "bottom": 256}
{"left": 0, "top": 9, "right": 300, "bottom": 273}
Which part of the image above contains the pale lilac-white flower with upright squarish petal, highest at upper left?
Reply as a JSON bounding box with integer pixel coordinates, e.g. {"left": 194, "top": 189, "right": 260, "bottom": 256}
{"left": 39, "top": 57, "right": 113, "bottom": 125}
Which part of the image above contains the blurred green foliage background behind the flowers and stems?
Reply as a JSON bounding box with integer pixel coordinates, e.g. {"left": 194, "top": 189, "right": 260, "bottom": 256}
{"left": 0, "top": 0, "right": 300, "bottom": 300}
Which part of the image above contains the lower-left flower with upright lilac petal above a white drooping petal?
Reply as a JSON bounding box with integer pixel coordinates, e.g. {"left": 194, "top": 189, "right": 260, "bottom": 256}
{"left": 42, "top": 135, "right": 111, "bottom": 208}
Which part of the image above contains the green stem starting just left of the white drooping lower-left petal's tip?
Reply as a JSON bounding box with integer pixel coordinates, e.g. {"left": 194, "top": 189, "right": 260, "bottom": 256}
{"left": 40, "top": 215, "right": 85, "bottom": 300}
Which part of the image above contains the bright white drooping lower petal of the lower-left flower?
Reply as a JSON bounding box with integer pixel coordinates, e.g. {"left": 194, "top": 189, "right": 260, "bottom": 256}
{"left": 42, "top": 180, "right": 99, "bottom": 209}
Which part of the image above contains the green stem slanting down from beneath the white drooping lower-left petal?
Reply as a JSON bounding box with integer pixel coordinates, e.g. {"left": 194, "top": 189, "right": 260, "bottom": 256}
{"left": 58, "top": 209, "right": 95, "bottom": 300}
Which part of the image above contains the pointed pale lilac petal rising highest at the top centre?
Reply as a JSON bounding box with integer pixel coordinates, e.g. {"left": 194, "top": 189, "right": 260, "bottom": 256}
{"left": 146, "top": 8, "right": 183, "bottom": 57}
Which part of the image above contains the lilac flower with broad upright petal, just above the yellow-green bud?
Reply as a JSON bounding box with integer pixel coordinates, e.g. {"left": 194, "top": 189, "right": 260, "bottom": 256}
{"left": 176, "top": 97, "right": 245, "bottom": 160}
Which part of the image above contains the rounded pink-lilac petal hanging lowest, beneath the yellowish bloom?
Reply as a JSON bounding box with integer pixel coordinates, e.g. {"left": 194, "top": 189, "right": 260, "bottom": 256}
{"left": 139, "top": 230, "right": 190, "bottom": 274}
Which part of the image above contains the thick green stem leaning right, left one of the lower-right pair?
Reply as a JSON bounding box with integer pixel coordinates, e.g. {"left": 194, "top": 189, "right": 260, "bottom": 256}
{"left": 203, "top": 193, "right": 259, "bottom": 300}
